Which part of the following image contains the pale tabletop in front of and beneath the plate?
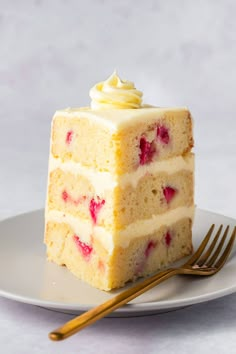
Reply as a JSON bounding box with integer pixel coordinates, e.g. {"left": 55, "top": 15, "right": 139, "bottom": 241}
{"left": 0, "top": 295, "right": 236, "bottom": 354}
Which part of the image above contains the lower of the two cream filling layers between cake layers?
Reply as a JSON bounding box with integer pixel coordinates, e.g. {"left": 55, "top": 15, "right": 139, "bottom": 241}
{"left": 45, "top": 206, "right": 195, "bottom": 253}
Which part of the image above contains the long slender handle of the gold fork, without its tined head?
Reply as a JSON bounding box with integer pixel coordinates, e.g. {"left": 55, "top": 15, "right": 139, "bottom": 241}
{"left": 49, "top": 268, "right": 179, "bottom": 341}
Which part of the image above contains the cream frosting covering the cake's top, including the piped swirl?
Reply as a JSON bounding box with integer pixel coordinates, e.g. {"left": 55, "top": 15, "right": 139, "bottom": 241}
{"left": 54, "top": 72, "right": 188, "bottom": 130}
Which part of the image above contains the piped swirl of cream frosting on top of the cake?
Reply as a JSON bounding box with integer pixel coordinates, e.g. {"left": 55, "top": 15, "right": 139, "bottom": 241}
{"left": 89, "top": 72, "right": 143, "bottom": 109}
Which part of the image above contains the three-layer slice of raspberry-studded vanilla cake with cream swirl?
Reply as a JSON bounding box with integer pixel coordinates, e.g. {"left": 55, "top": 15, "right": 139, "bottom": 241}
{"left": 45, "top": 74, "right": 194, "bottom": 290}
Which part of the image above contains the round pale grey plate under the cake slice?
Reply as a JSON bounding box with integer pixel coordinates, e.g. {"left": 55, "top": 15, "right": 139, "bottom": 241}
{"left": 0, "top": 209, "right": 236, "bottom": 317}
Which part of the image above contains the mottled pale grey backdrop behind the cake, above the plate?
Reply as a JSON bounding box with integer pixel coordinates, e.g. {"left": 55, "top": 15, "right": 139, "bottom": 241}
{"left": 0, "top": 0, "right": 236, "bottom": 217}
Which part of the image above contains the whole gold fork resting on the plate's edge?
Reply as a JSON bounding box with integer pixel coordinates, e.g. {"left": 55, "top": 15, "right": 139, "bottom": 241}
{"left": 49, "top": 224, "right": 236, "bottom": 341}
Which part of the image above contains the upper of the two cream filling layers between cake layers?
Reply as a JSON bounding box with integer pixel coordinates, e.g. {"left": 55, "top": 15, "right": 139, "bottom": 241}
{"left": 49, "top": 153, "right": 194, "bottom": 196}
